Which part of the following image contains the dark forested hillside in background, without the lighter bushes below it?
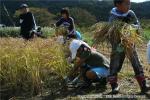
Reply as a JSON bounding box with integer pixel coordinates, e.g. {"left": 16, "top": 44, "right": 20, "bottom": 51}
{"left": 0, "top": 0, "right": 150, "bottom": 25}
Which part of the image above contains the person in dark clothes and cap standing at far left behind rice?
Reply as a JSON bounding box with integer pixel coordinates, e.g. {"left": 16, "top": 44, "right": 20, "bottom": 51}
{"left": 19, "top": 4, "right": 36, "bottom": 40}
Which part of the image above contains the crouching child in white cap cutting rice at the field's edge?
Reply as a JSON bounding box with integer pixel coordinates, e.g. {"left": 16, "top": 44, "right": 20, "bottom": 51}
{"left": 69, "top": 39, "right": 109, "bottom": 86}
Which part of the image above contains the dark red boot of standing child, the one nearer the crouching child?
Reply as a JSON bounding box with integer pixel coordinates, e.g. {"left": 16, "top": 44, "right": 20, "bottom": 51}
{"left": 108, "top": 76, "right": 120, "bottom": 94}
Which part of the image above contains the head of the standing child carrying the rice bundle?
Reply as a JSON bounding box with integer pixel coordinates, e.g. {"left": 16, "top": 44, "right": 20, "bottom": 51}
{"left": 114, "top": 0, "right": 131, "bottom": 13}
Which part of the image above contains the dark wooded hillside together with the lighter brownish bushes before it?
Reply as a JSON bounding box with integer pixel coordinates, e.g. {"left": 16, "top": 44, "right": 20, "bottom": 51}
{"left": 0, "top": 0, "right": 150, "bottom": 27}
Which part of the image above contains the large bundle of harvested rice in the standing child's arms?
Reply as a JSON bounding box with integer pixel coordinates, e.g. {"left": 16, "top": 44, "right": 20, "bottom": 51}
{"left": 94, "top": 22, "right": 142, "bottom": 57}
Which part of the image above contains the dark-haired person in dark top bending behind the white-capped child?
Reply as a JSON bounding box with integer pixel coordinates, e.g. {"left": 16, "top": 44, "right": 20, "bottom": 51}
{"left": 56, "top": 8, "right": 82, "bottom": 40}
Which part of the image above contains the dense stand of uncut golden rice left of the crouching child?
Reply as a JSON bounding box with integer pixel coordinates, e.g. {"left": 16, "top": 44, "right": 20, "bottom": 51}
{"left": 0, "top": 38, "right": 68, "bottom": 95}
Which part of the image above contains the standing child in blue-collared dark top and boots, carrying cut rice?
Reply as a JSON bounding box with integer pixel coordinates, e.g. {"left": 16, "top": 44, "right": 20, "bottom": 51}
{"left": 108, "top": 0, "right": 150, "bottom": 94}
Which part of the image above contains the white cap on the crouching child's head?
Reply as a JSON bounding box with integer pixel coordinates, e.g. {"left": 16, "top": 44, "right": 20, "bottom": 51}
{"left": 69, "top": 39, "right": 91, "bottom": 60}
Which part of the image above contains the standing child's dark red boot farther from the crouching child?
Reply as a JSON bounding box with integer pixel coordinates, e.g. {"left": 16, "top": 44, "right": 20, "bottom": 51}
{"left": 136, "top": 75, "right": 150, "bottom": 94}
